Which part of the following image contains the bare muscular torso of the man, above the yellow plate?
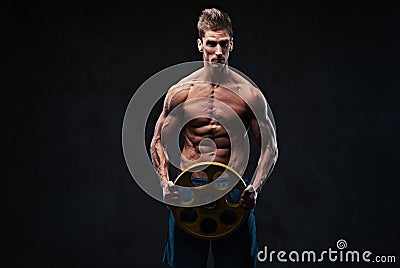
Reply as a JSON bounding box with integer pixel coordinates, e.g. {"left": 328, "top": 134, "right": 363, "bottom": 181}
{"left": 166, "top": 69, "right": 254, "bottom": 173}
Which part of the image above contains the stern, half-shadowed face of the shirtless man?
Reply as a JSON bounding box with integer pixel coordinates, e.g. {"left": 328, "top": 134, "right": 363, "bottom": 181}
{"left": 197, "top": 30, "right": 233, "bottom": 64}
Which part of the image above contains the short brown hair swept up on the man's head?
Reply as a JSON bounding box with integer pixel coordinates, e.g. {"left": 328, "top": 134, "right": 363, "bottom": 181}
{"left": 197, "top": 8, "right": 233, "bottom": 39}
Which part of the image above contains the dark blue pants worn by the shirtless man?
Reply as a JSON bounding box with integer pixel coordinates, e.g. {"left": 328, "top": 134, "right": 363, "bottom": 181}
{"left": 163, "top": 177, "right": 258, "bottom": 268}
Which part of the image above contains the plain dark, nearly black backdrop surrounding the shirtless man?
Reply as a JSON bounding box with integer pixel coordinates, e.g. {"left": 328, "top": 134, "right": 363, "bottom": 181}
{"left": 0, "top": 0, "right": 400, "bottom": 267}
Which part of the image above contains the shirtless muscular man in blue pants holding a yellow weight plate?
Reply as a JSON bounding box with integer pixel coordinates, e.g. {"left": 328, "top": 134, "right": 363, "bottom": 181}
{"left": 151, "top": 8, "right": 277, "bottom": 268}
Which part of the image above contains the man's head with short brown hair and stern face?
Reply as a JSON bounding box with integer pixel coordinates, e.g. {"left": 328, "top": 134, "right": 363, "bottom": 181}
{"left": 197, "top": 8, "right": 233, "bottom": 65}
